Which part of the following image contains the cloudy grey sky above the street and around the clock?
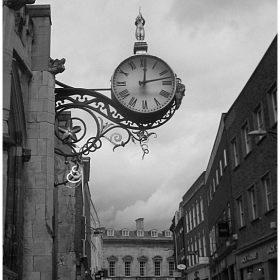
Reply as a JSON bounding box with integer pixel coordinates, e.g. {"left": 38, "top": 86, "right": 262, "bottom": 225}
{"left": 36, "top": 0, "right": 277, "bottom": 230}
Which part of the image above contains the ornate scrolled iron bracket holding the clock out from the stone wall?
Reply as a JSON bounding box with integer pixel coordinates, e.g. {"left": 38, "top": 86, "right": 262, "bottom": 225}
{"left": 55, "top": 79, "right": 184, "bottom": 186}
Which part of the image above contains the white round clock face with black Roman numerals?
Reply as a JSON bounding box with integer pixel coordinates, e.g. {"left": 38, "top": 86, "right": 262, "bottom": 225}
{"left": 112, "top": 54, "right": 176, "bottom": 114}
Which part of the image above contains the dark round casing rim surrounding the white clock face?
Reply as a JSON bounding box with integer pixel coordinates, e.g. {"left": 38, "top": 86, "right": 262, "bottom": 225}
{"left": 111, "top": 53, "right": 176, "bottom": 124}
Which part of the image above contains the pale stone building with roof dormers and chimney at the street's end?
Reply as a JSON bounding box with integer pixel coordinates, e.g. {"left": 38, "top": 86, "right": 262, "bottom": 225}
{"left": 103, "top": 218, "right": 175, "bottom": 280}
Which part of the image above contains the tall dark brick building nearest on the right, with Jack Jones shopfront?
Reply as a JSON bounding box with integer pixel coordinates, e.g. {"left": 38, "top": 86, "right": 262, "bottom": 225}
{"left": 225, "top": 37, "right": 277, "bottom": 280}
